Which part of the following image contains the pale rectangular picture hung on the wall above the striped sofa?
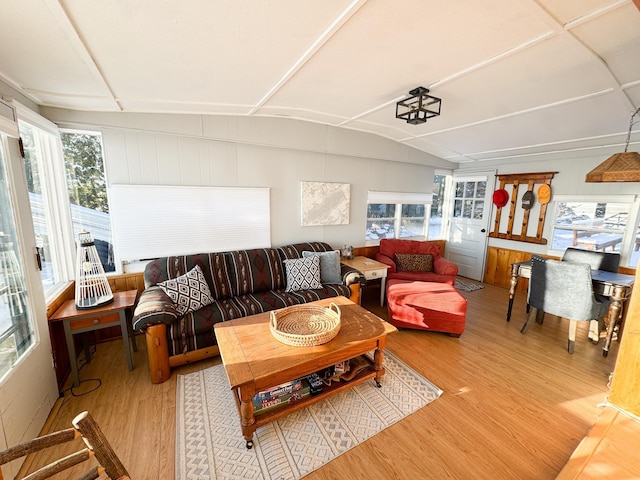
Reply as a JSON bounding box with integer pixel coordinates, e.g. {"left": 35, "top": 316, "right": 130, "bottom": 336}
{"left": 300, "top": 182, "right": 351, "bottom": 227}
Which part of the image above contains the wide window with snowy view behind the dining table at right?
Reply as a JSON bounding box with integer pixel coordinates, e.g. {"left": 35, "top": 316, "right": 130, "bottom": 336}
{"left": 551, "top": 196, "right": 640, "bottom": 266}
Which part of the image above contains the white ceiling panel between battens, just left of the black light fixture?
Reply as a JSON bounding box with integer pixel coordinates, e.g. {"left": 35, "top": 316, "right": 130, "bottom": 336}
{"left": 262, "top": 0, "right": 549, "bottom": 117}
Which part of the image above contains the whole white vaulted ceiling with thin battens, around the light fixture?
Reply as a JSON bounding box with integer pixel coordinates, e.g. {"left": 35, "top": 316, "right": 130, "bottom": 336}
{"left": 0, "top": 0, "right": 640, "bottom": 162}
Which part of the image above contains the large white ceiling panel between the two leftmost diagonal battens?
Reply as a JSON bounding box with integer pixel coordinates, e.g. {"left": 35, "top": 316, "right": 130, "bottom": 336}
{"left": 64, "top": 0, "right": 348, "bottom": 105}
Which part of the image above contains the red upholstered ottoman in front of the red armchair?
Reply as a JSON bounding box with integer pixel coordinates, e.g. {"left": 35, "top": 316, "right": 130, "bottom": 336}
{"left": 387, "top": 280, "right": 467, "bottom": 335}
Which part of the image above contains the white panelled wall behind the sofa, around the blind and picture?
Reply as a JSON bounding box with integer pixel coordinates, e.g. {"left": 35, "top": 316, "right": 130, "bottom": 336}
{"left": 42, "top": 107, "right": 454, "bottom": 248}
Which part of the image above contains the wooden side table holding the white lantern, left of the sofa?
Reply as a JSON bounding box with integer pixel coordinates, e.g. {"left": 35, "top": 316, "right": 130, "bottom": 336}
{"left": 49, "top": 290, "right": 138, "bottom": 387}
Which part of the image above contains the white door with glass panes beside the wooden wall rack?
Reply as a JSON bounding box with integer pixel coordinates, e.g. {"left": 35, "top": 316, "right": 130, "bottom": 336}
{"left": 447, "top": 171, "right": 495, "bottom": 281}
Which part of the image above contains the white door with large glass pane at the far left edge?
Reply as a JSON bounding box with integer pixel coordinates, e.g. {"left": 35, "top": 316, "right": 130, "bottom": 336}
{"left": 0, "top": 122, "right": 58, "bottom": 478}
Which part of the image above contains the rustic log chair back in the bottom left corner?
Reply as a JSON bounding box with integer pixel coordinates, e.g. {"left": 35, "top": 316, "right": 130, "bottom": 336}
{"left": 0, "top": 412, "right": 130, "bottom": 480}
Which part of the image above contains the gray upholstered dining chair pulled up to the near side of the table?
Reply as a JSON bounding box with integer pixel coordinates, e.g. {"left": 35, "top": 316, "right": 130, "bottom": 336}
{"left": 520, "top": 255, "right": 609, "bottom": 353}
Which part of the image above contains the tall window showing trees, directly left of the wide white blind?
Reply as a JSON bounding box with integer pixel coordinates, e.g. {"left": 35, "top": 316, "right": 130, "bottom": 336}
{"left": 60, "top": 131, "right": 115, "bottom": 272}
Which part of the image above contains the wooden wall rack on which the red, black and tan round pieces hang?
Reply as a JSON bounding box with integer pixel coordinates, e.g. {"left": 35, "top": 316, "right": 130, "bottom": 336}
{"left": 489, "top": 172, "right": 558, "bottom": 245}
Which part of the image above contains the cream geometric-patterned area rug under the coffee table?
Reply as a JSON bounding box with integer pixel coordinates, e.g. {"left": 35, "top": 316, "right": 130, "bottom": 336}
{"left": 176, "top": 351, "right": 442, "bottom": 480}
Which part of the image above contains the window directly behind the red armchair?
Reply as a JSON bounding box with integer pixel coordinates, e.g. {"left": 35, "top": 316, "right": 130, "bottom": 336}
{"left": 365, "top": 192, "right": 431, "bottom": 244}
